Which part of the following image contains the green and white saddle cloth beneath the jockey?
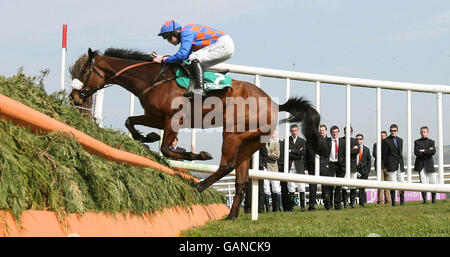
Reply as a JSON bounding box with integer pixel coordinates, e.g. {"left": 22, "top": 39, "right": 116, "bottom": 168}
{"left": 175, "top": 63, "right": 233, "bottom": 93}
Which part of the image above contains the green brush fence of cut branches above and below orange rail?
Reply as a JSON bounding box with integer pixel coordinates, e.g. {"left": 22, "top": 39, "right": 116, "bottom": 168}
{"left": 0, "top": 70, "right": 225, "bottom": 222}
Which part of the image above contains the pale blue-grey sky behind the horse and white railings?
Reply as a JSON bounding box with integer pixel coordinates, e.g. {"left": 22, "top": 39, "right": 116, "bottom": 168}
{"left": 0, "top": 0, "right": 450, "bottom": 163}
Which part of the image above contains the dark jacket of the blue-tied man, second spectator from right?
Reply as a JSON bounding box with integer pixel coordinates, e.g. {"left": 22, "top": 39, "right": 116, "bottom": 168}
{"left": 381, "top": 136, "right": 405, "bottom": 172}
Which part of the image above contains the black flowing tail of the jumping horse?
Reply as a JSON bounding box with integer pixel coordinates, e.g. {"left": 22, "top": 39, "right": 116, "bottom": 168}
{"left": 279, "top": 97, "right": 322, "bottom": 153}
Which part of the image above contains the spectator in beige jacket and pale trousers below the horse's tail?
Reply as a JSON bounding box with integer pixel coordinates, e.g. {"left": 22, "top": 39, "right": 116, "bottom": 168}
{"left": 264, "top": 129, "right": 281, "bottom": 212}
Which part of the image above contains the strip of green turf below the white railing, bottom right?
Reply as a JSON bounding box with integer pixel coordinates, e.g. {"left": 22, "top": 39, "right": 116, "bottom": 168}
{"left": 182, "top": 200, "right": 450, "bottom": 237}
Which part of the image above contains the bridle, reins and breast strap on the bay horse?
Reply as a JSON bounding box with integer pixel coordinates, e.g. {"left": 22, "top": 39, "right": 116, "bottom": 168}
{"left": 78, "top": 55, "right": 175, "bottom": 99}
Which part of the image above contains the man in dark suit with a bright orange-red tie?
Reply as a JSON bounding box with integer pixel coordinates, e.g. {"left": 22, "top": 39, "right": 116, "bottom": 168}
{"left": 356, "top": 134, "right": 372, "bottom": 207}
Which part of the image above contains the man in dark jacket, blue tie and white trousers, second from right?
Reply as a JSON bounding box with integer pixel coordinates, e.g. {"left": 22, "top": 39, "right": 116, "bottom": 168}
{"left": 381, "top": 124, "right": 405, "bottom": 206}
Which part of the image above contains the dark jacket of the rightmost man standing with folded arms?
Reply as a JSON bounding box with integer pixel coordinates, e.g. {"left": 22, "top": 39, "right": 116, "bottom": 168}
{"left": 414, "top": 138, "right": 436, "bottom": 173}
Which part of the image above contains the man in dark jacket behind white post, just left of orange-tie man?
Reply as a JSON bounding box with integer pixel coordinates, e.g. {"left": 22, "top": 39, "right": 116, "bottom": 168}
{"left": 339, "top": 126, "right": 359, "bottom": 209}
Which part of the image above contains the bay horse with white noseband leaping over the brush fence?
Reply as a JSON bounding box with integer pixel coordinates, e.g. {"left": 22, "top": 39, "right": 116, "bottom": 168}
{"left": 71, "top": 48, "right": 321, "bottom": 220}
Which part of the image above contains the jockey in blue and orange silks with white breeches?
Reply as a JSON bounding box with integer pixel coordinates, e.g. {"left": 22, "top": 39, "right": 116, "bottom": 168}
{"left": 153, "top": 20, "right": 234, "bottom": 97}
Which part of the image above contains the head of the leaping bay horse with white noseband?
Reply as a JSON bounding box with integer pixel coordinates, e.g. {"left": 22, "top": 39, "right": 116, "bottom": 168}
{"left": 70, "top": 48, "right": 106, "bottom": 105}
